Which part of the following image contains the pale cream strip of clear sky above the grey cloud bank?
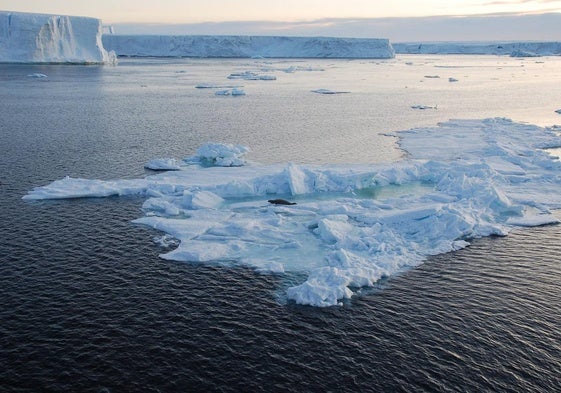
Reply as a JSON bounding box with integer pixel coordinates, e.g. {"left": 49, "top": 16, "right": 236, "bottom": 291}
{"left": 0, "top": 0, "right": 561, "bottom": 24}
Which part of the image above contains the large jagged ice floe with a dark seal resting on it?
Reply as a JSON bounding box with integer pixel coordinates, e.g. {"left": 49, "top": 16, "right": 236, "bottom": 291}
{"left": 23, "top": 119, "right": 561, "bottom": 306}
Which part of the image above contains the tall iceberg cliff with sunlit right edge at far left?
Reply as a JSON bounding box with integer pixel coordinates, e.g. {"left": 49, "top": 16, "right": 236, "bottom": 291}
{"left": 0, "top": 11, "right": 115, "bottom": 64}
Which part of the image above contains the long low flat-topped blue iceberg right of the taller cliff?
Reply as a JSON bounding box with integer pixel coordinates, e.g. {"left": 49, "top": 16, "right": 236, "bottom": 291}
{"left": 103, "top": 35, "right": 395, "bottom": 59}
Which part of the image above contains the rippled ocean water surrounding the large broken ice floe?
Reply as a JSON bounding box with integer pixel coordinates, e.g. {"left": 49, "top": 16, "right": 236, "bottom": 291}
{"left": 0, "top": 56, "right": 561, "bottom": 392}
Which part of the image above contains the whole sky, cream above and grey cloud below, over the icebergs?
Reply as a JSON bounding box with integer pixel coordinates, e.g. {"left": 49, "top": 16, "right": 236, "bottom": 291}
{"left": 0, "top": 0, "right": 561, "bottom": 40}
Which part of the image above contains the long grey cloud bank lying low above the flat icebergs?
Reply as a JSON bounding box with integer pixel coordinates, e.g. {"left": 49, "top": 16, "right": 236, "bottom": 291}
{"left": 111, "top": 13, "right": 561, "bottom": 42}
